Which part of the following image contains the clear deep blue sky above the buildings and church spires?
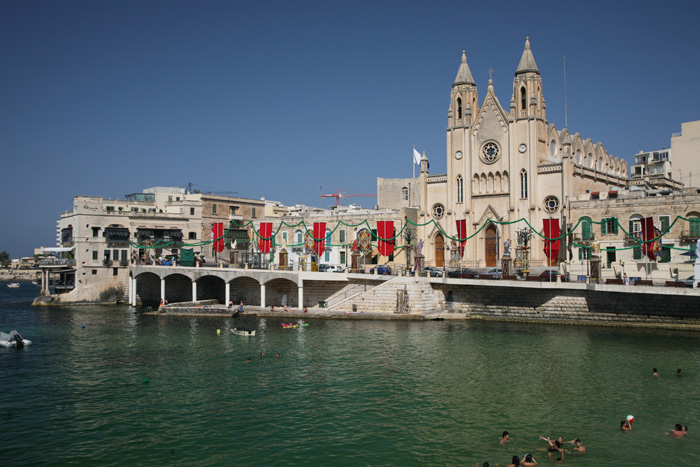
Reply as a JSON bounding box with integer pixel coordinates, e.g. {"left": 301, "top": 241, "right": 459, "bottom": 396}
{"left": 0, "top": 0, "right": 700, "bottom": 257}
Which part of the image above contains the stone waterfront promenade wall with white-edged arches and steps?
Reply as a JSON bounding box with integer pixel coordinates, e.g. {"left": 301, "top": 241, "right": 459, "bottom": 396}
{"left": 135, "top": 266, "right": 700, "bottom": 330}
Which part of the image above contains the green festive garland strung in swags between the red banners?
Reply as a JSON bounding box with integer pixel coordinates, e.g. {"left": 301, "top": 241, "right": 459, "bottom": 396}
{"left": 130, "top": 216, "right": 700, "bottom": 251}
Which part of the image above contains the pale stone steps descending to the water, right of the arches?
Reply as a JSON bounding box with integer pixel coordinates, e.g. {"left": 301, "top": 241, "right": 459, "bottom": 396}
{"left": 329, "top": 277, "right": 445, "bottom": 315}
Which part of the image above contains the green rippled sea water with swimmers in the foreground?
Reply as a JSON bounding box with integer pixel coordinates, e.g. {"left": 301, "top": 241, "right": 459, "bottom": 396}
{"left": 0, "top": 284, "right": 700, "bottom": 466}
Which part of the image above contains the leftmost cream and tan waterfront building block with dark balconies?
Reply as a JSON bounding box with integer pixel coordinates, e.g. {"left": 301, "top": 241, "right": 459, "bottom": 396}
{"left": 52, "top": 187, "right": 264, "bottom": 302}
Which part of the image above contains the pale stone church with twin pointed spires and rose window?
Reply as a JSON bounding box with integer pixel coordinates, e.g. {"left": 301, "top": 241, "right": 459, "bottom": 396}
{"left": 377, "top": 38, "right": 628, "bottom": 267}
